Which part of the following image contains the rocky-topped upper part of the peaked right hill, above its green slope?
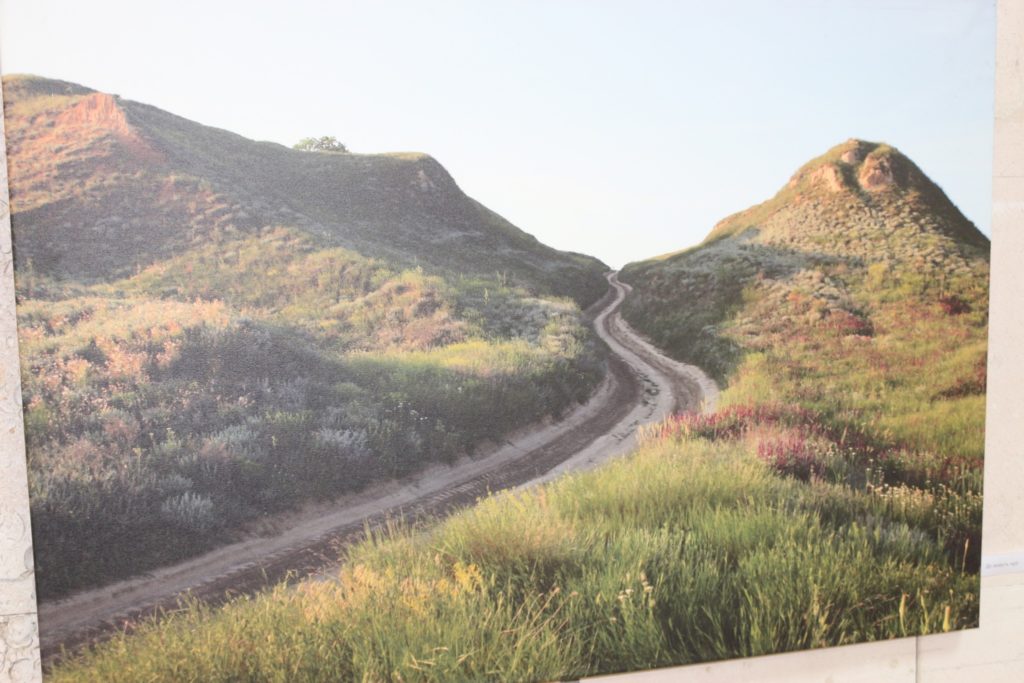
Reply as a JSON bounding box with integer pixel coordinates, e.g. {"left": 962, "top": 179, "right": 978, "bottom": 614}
{"left": 621, "top": 139, "right": 989, "bottom": 381}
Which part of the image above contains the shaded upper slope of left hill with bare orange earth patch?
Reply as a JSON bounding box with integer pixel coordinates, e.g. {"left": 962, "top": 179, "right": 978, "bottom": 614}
{"left": 3, "top": 76, "right": 605, "bottom": 305}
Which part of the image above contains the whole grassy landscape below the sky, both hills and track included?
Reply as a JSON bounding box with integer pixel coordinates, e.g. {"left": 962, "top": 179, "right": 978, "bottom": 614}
{"left": 3, "top": 77, "right": 989, "bottom": 682}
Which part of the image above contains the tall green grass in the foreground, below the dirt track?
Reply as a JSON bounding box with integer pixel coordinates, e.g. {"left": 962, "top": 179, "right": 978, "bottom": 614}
{"left": 51, "top": 432, "right": 978, "bottom": 682}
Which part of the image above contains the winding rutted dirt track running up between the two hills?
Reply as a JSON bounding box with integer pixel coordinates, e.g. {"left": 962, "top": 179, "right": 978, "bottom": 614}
{"left": 39, "top": 273, "right": 718, "bottom": 660}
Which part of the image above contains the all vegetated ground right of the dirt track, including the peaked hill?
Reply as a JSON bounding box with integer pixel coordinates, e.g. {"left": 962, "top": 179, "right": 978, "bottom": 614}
{"left": 53, "top": 140, "right": 987, "bottom": 681}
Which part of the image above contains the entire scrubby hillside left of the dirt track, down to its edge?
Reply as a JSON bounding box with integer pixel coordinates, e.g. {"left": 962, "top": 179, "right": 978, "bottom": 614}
{"left": 3, "top": 77, "right": 606, "bottom": 598}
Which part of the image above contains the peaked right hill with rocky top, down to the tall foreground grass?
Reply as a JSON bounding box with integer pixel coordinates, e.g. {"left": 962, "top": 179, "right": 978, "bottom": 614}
{"left": 622, "top": 140, "right": 989, "bottom": 567}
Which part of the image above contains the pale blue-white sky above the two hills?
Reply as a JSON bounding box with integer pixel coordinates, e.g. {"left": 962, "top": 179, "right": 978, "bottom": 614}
{"left": 0, "top": 0, "right": 995, "bottom": 267}
